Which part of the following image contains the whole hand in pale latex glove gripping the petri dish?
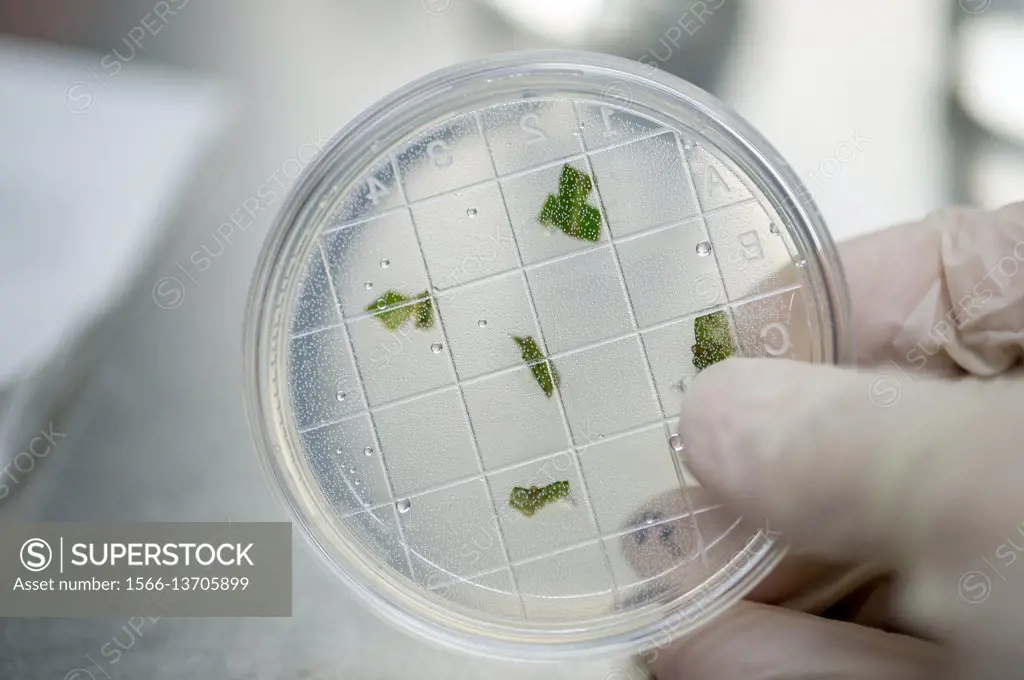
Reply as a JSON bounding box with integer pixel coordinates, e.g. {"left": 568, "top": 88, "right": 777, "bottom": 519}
{"left": 652, "top": 203, "right": 1024, "bottom": 680}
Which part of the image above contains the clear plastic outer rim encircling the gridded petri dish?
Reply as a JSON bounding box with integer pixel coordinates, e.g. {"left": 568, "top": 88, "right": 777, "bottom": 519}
{"left": 244, "top": 50, "right": 853, "bottom": 661}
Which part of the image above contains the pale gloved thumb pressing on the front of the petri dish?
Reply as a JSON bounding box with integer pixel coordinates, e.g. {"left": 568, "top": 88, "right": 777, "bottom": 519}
{"left": 680, "top": 358, "right": 1024, "bottom": 568}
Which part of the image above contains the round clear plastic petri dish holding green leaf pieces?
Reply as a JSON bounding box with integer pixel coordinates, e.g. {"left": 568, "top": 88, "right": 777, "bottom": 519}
{"left": 246, "top": 51, "right": 850, "bottom": 661}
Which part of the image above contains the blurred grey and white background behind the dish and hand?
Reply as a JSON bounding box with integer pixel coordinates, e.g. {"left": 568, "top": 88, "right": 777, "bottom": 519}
{"left": 0, "top": 0, "right": 1024, "bottom": 680}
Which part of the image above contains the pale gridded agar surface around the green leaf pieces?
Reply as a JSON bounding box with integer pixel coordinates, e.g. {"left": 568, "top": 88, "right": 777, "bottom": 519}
{"left": 285, "top": 98, "right": 821, "bottom": 626}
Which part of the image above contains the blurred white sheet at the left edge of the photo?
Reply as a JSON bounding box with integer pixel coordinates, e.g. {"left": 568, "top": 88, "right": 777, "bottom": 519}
{"left": 0, "top": 39, "right": 229, "bottom": 385}
